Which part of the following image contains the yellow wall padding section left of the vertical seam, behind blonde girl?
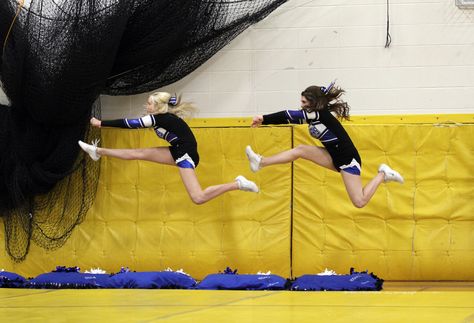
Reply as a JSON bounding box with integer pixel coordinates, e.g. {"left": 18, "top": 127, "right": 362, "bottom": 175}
{"left": 0, "top": 127, "right": 292, "bottom": 279}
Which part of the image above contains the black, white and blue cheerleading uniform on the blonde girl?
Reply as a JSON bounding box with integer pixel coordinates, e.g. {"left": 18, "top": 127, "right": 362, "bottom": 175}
{"left": 101, "top": 113, "right": 199, "bottom": 168}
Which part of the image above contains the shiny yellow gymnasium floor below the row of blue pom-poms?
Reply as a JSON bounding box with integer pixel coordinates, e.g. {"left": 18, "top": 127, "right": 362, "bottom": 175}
{"left": 0, "top": 282, "right": 474, "bottom": 323}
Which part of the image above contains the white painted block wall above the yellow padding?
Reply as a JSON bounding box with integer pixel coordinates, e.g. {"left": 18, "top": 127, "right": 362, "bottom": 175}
{"left": 0, "top": 0, "right": 474, "bottom": 118}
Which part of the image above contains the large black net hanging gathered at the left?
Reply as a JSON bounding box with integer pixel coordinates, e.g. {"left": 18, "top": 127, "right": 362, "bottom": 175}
{"left": 0, "top": 0, "right": 286, "bottom": 261}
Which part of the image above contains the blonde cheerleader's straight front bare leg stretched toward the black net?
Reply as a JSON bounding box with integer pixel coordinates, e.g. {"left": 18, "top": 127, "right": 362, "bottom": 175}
{"left": 97, "top": 147, "right": 175, "bottom": 165}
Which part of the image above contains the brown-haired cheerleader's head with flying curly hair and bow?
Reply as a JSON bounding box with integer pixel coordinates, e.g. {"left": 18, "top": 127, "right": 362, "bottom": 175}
{"left": 301, "top": 85, "right": 350, "bottom": 120}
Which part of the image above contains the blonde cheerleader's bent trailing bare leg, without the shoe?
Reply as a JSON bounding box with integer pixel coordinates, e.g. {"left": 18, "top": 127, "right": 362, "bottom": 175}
{"left": 179, "top": 168, "right": 239, "bottom": 204}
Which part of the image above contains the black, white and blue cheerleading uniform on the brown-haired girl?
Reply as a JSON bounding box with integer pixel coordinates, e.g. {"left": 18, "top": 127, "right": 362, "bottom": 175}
{"left": 262, "top": 108, "right": 362, "bottom": 175}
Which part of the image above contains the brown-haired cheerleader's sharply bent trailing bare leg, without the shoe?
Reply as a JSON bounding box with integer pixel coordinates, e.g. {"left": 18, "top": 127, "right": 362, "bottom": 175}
{"left": 341, "top": 170, "right": 385, "bottom": 208}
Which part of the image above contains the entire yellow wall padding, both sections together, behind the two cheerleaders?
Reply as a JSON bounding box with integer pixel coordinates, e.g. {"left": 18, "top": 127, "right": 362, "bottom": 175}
{"left": 0, "top": 116, "right": 474, "bottom": 280}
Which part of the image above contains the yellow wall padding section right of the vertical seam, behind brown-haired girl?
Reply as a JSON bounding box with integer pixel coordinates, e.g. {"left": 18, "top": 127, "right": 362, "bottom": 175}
{"left": 292, "top": 124, "right": 474, "bottom": 280}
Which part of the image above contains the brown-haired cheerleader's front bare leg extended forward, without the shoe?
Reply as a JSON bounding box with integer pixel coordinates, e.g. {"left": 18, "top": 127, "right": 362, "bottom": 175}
{"left": 260, "top": 145, "right": 336, "bottom": 171}
